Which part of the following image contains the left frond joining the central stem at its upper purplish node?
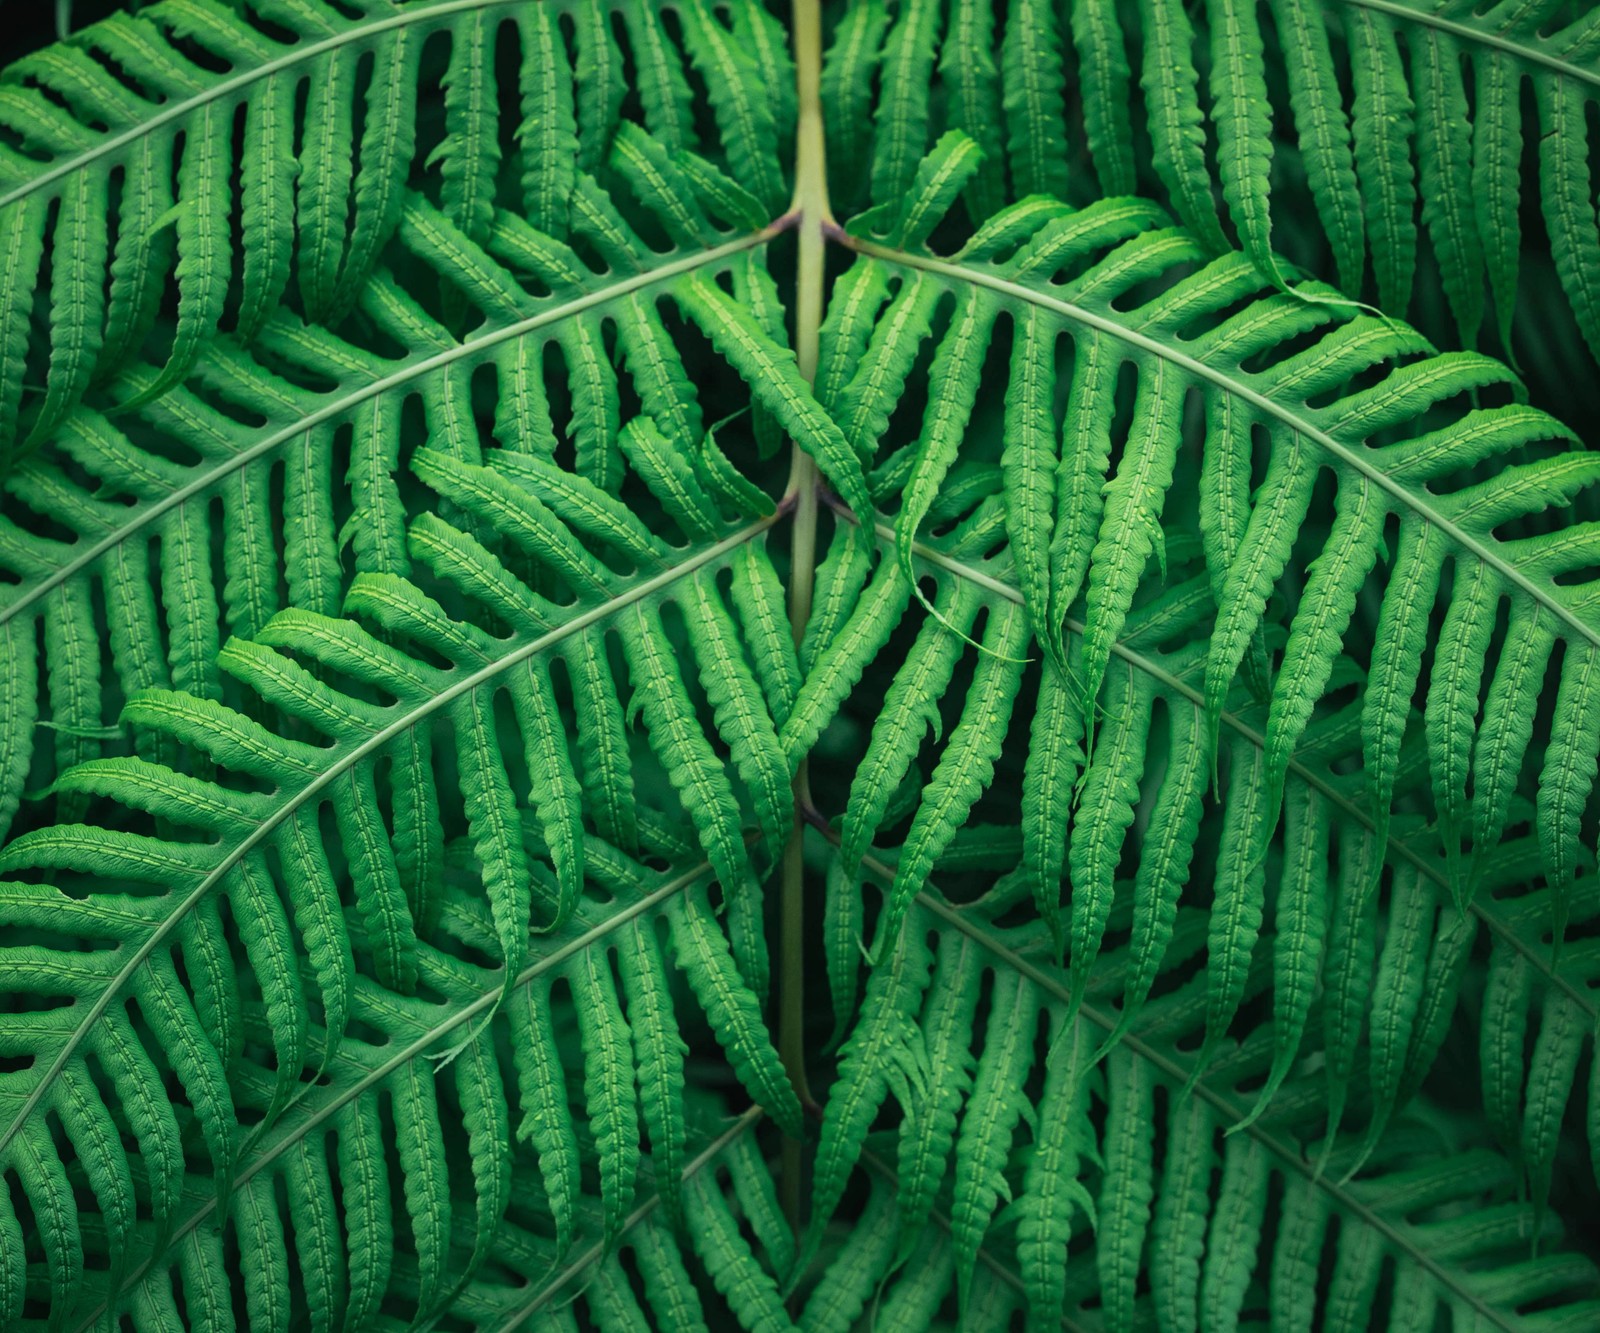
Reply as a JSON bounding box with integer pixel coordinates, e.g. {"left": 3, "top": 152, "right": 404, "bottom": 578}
{"left": 0, "top": 133, "right": 853, "bottom": 844}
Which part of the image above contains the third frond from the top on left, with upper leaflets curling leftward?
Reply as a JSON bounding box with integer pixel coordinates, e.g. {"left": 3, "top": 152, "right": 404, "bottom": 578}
{"left": 5, "top": 390, "right": 819, "bottom": 1305}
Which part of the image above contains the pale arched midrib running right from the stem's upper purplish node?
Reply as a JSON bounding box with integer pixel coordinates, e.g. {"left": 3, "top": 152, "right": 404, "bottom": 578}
{"left": 857, "top": 240, "right": 1600, "bottom": 648}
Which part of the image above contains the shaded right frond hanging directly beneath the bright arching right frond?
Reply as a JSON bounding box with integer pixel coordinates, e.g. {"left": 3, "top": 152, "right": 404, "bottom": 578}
{"left": 812, "top": 451, "right": 1600, "bottom": 1200}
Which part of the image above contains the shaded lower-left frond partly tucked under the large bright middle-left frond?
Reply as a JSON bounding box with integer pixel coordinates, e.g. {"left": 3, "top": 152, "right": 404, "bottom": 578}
{"left": 3, "top": 829, "right": 797, "bottom": 1330}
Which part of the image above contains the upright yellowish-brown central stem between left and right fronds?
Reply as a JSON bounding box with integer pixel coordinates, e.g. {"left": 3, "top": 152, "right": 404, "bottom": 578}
{"left": 778, "top": 0, "right": 832, "bottom": 1234}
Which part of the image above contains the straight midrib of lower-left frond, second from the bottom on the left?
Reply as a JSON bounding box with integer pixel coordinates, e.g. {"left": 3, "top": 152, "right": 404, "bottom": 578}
{"left": 75, "top": 861, "right": 723, "bottom": 1333}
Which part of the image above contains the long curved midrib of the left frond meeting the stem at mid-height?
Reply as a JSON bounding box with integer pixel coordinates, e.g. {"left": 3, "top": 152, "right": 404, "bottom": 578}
{"left": 0, "top": 498, "right": 780, "bottom": 1152}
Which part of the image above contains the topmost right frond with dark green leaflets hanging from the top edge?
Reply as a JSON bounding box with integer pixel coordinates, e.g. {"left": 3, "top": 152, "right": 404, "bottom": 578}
{"left": 829, "top": 0, "right": 1600, "bottom": 355}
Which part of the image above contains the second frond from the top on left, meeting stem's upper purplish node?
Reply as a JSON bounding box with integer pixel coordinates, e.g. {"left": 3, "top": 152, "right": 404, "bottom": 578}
{"left": 0, "top": 145, "right": 856, "bottom": 821}
